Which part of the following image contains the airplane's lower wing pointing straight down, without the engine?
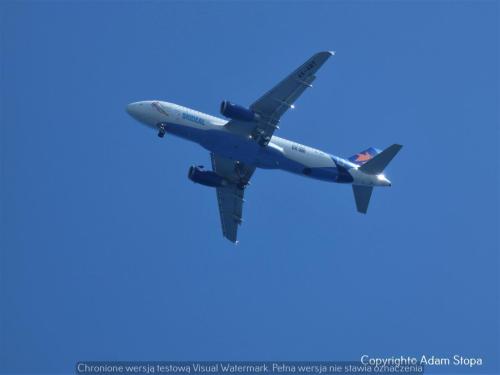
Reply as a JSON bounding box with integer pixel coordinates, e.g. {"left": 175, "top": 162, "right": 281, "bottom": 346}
{"left": 211, "top": 153, "right": 255, "bottom": 242}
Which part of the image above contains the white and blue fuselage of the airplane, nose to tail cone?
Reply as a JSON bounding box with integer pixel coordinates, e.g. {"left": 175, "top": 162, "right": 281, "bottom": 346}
{"left": 127, "top": 101, "right": 390, "bottom": 186}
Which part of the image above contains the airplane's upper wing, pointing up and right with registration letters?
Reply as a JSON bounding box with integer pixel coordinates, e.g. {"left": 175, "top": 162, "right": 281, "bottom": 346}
{"left": 226, "top": 52, "right": 334, "bottom": 146}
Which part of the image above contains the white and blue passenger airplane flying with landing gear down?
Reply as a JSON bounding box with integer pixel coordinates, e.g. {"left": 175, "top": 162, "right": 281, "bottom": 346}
{"left": 126, "top": 51, "right": 402, "bottom": 243}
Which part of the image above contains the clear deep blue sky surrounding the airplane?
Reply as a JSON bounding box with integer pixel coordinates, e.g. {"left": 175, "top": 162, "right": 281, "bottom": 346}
{"left": 0, "top": 1, "right": 500, "bottom": 373}
